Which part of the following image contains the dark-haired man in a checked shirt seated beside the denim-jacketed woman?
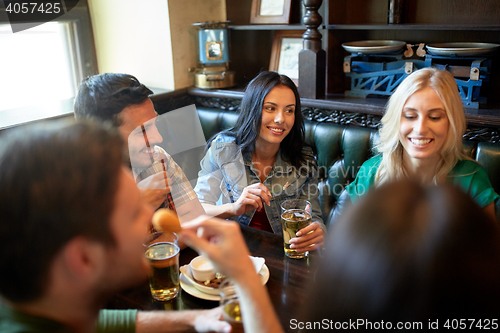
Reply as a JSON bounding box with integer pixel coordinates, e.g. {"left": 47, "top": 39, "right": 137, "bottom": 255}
{"left": 74, "top": 73, "right": 205, "bottom": 221}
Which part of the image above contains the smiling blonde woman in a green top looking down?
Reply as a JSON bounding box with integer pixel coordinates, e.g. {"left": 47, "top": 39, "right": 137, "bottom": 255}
{"left": 346, "top": 68, "right": 499, "bottom": 218}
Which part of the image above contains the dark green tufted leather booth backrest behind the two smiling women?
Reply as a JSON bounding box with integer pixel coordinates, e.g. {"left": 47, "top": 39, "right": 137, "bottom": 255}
{"left": 195, "top": 106, "right": 500, "bottom": 226}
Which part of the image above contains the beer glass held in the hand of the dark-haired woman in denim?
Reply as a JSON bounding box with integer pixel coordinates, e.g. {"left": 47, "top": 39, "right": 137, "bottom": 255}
{"left": 281, "top": 199, "right": 312, "bottom": 259}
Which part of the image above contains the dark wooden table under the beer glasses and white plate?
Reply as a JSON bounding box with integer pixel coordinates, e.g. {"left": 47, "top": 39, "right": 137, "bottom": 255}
{"left": 107, "top": 226, "right": 319, "bottom": 332}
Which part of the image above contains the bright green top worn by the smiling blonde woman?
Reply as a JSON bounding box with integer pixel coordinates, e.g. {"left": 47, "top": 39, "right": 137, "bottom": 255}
{"left": 346, "top": 155, "right": 499, "bottom": 208}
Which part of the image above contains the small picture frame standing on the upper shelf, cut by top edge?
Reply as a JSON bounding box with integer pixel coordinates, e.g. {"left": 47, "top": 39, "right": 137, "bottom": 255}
{"left": 250, "top": 0, "right": 292, "bottom": 24}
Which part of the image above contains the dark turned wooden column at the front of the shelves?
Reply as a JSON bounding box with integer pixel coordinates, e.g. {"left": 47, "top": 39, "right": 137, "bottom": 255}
{"left": 299, "top": 0, "right": 326, "bottom": 98}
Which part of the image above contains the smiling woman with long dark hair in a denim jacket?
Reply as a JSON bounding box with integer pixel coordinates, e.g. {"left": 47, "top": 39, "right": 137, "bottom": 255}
{"left": 195, "top": 72, "right": 325, "bottom": 252}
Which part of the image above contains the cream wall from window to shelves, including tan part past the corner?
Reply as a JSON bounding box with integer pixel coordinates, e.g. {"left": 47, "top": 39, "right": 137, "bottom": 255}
{"left": 89, "top": 0, "right": 226, "bottom": 90}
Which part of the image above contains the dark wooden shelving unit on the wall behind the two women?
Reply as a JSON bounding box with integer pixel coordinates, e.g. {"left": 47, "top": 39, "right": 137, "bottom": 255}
{"left": 225, "top": 0, "right": 500, "bottom": 128}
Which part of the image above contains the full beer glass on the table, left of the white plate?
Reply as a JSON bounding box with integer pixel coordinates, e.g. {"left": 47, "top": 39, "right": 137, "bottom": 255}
{"left": 145, "top": 232, "right": 180, "bottom": 301}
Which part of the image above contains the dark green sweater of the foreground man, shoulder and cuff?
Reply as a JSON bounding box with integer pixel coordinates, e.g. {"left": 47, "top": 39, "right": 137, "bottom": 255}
{"left": 0, "top": 302, "right": 137, "bottom": 333}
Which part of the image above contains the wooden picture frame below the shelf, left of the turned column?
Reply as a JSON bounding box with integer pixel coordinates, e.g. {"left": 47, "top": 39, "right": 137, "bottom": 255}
{"left": 269, "top": 30, "right": 305, "bottom": 87}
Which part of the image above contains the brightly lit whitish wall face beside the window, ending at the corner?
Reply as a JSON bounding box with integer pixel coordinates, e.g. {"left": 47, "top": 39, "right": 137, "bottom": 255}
{"left": 89, "top": 0, "right": 174, "bottom": 89}
